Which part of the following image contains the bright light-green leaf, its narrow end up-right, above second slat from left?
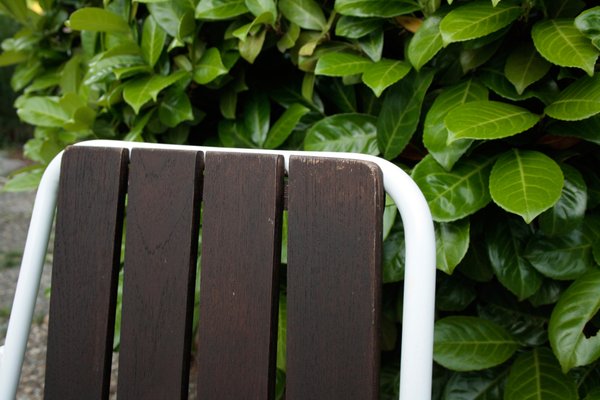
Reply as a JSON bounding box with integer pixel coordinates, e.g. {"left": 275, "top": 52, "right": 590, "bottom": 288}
{"left": 123, "top": 71, "right": 188, "bottom": 114}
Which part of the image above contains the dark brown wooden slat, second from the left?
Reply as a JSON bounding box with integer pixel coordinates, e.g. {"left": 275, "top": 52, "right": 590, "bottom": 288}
{"left": 117, "top": 149, "right": 202, "bottom": 400}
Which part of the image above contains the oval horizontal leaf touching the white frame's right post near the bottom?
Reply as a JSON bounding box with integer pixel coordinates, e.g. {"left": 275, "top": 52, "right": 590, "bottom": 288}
{"left": 433, "top": 316, "right": 518, "bottom": 371}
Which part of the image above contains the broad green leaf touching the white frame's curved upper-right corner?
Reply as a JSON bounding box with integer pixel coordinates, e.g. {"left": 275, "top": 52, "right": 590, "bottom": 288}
{"left": 412, "top": 156, "right": 494, "bottom": 222}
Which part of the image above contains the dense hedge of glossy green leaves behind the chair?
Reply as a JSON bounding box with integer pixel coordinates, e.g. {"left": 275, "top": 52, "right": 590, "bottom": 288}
{"left": 0, "top": 0, "right": 600, "bottom": 400}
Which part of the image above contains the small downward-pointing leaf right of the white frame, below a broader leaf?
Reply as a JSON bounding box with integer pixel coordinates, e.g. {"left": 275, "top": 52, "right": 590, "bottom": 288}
{"left": 435, "top": 218, "right": 470, "bottom": 275}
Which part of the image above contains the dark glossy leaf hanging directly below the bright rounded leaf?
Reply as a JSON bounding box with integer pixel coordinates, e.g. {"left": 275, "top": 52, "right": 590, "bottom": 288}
{"left": 486, "top": 218, "right": 542, "bottom": 300}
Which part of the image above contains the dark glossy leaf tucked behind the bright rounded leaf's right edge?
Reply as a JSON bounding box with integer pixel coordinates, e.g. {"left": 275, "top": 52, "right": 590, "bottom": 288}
{"left": 539, "top": 164, "right": 587, "bottom": 236}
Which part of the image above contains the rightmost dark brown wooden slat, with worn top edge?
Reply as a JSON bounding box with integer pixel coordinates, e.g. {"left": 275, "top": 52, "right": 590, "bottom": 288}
{"left": 286, "top": 157, "right": 384, "bottom": 400}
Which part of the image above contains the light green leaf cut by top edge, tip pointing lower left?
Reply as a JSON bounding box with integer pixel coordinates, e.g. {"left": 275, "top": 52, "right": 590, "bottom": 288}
{"left": 440, "top": 0, "right": 523, "bottom": 44}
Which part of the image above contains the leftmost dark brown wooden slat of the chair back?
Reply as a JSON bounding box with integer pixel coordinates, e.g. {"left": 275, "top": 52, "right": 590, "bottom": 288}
{"left": 45, "top": 147, "right": 128, "bottom": 400}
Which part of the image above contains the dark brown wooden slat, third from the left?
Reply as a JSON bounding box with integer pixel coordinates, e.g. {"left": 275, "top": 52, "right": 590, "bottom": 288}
{"left": 197, "top": 153, "right": 283, "bottom": 400}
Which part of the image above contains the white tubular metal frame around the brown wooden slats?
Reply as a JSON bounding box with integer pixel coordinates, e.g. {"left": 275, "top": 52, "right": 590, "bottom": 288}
{"left": 0, "top": 140, "right": 436, "bottom": 400}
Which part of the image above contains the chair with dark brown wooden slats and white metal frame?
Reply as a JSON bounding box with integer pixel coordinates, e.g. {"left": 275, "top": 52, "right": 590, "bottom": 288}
{"left": 0, "top": 141, "right": 435, "bottom": 400}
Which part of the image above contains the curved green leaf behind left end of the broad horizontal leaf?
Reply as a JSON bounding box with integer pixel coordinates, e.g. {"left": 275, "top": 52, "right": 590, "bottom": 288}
{"left": 423, "top": 80, "right": 488, "bottom": 170}
